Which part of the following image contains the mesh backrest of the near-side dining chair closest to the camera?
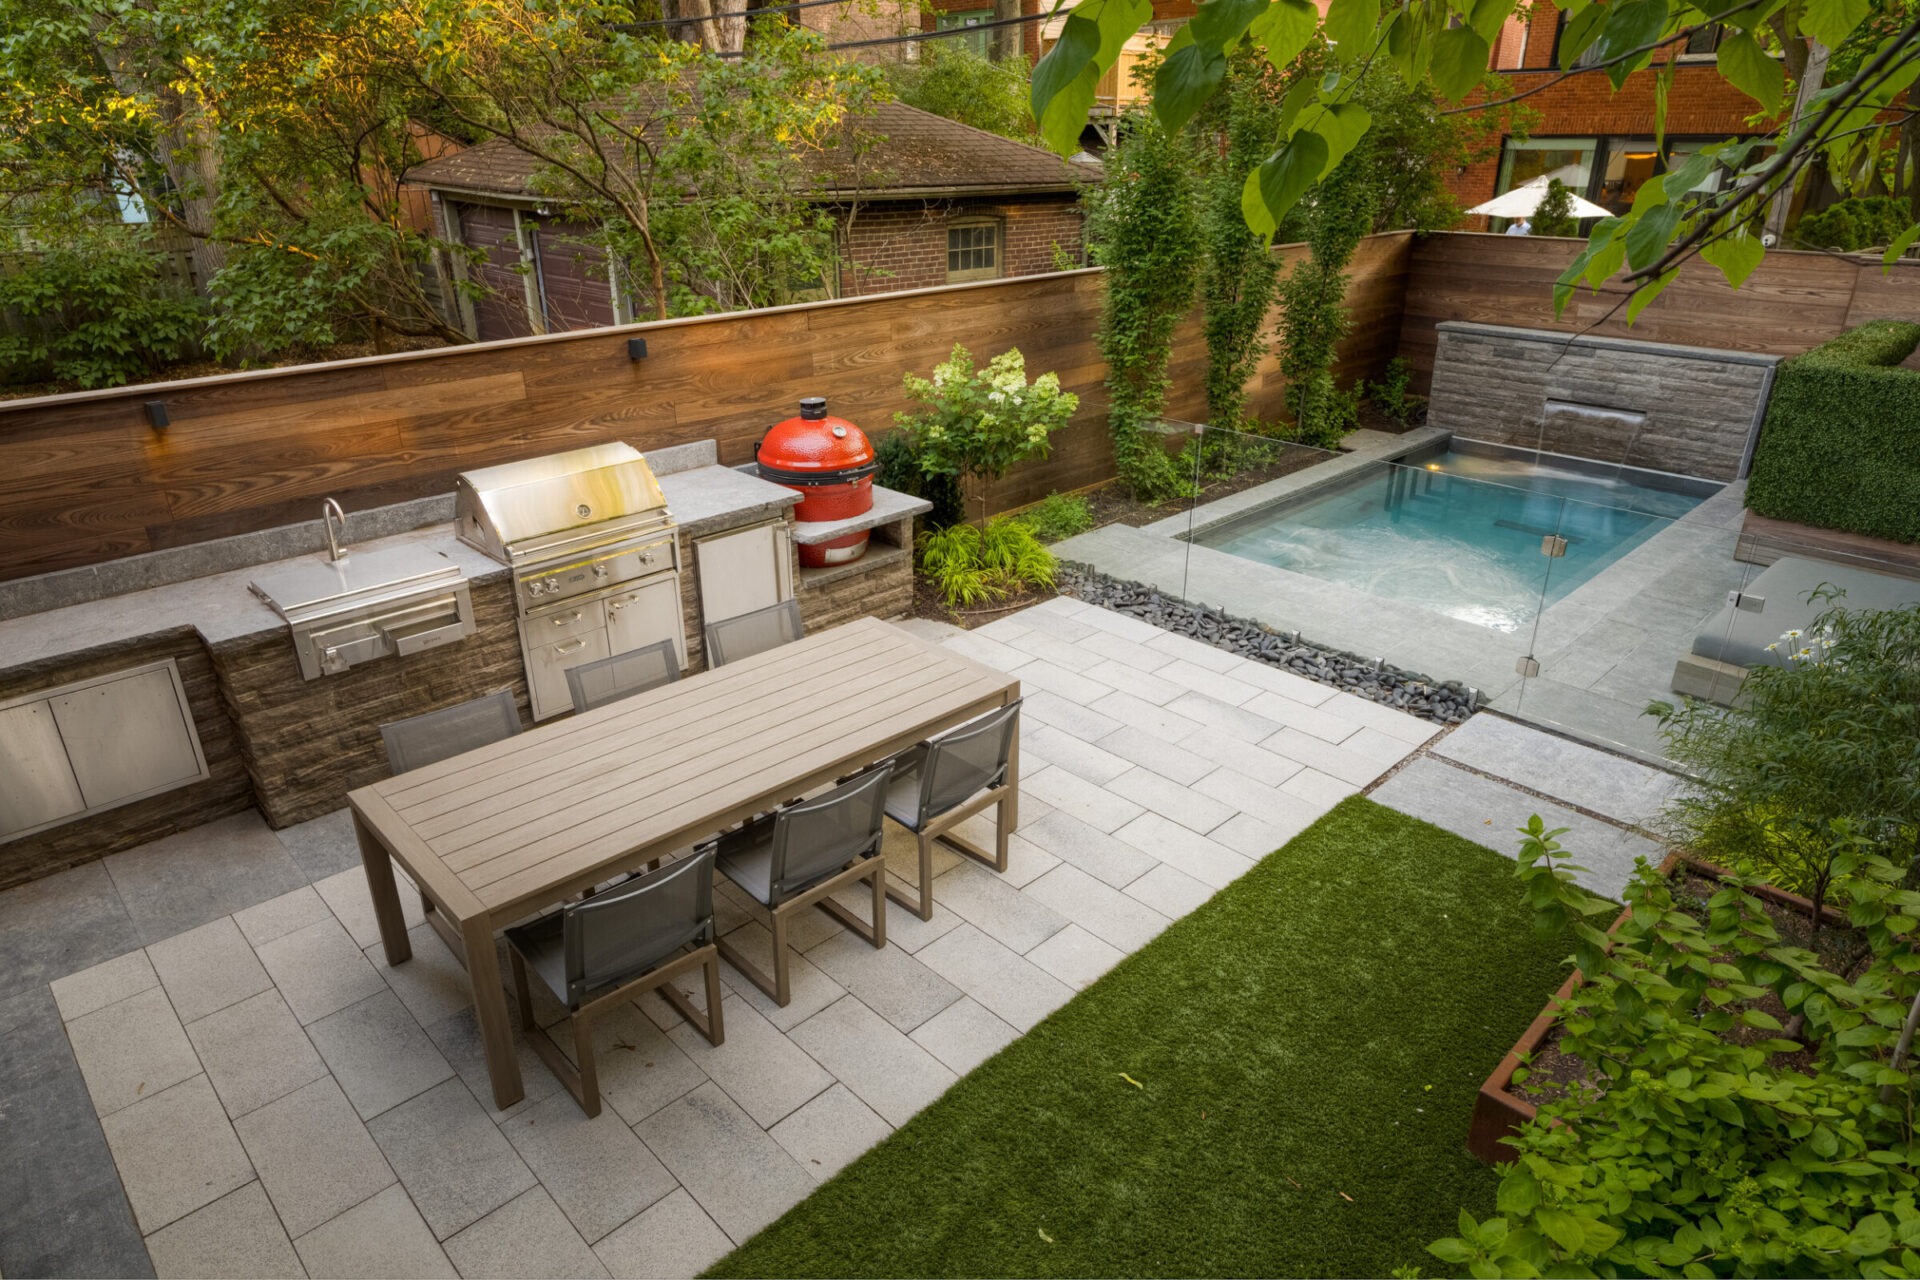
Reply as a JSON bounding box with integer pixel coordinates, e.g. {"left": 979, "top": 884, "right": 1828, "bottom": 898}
{"left": 564, "top": 848, "right": 714, "bottom": 1009}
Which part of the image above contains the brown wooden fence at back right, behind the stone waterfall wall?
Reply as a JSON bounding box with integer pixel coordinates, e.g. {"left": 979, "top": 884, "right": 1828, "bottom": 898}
{"left": 1400, "top": 232, "right": 1920, "bottom": 390}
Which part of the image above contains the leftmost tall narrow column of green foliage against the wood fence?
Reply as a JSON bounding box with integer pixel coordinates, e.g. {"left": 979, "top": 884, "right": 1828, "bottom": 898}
{"left": 1087, "top": 111, "right": 1202, "bottom": 501}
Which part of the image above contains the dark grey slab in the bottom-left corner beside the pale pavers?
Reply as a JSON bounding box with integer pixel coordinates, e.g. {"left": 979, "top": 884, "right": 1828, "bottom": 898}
{"left": 0, "top": 986, "right": 154, "bottom": 1276}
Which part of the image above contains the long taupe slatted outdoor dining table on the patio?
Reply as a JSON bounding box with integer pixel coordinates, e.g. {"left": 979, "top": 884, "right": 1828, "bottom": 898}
{"left": 348, "top": 618, "right": 1020, "bottom": 1107}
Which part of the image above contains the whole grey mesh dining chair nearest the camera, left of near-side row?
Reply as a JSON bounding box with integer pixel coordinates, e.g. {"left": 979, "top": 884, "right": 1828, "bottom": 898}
{"left": 507, "top": 850, "right": 726, "bottom": 1117}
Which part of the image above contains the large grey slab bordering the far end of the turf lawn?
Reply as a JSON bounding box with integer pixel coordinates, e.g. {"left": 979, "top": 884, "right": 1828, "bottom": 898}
{"left": 1373, "top": 756, "right": 1665, "bottom": 898}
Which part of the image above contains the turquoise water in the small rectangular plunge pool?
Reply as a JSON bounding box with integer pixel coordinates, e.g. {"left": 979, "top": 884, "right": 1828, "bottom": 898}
{"left": 1194, "top": 451, "right": 1713, "bottom": 631}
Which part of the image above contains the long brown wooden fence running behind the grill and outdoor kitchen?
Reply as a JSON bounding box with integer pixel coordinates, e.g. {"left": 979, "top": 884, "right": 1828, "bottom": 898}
{"left": 0, "top": 234, "right": 1413, "bottom": 580}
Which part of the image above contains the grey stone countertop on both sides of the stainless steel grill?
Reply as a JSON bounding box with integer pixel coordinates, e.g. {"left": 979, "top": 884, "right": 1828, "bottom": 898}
{"left": 0, "top": 464, "right": 801, "bottom": 674}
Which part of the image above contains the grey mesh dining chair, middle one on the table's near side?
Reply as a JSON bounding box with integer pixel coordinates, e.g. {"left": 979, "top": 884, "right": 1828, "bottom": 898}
{"left": 703, "top": 764, "right": 891, "bottom": 1006}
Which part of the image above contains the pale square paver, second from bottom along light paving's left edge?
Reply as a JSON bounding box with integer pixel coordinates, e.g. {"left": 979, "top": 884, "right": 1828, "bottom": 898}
{"left": 100, "top": 1075, "right": 253, "bottom": 1234}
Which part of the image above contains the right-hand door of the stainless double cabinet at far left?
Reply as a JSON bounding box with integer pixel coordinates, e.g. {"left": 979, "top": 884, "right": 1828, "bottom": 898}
{"left": 52, "top": 668, "right": 205, "bottom": 808}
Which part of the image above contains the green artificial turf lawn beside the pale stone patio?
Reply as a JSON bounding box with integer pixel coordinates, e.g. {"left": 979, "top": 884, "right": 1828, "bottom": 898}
{"left": 707, "top": 796, "right": 1571, "bottom": 1276}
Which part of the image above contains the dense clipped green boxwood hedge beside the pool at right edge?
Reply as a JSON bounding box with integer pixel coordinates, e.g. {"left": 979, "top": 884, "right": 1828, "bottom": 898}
{"left": 1747, "top": 320, "right": 1920, "bottom": 543}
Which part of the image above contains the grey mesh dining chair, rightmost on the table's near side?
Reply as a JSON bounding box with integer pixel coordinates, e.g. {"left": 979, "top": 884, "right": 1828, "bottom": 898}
{"left": 887, "top": 699, "right": 1020, "bottom": 919}
